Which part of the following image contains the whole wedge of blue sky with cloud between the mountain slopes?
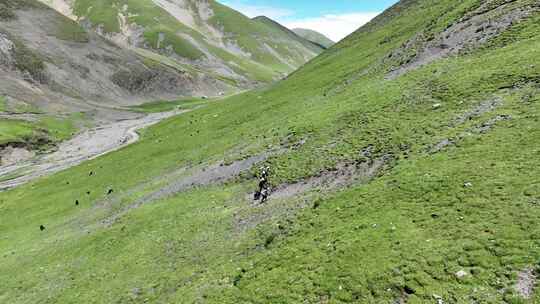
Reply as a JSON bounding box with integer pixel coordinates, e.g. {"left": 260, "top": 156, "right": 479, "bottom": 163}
{"left": 218, "top": 0, "right": 397, "bottom": 41}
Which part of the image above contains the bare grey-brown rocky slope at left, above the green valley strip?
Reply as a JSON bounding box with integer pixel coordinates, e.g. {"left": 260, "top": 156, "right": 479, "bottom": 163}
{"left": 0, "top": 1, "right": 227, "bottom": 112}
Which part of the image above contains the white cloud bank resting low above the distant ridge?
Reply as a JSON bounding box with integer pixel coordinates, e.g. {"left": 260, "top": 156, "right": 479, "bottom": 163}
{"left": 282, "top": 12, "right": 379, "bottom": 41}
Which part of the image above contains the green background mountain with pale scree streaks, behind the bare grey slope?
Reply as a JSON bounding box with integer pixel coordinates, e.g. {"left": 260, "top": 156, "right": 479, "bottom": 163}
{"left": 42, "top": 0, "right": 322, "bottom": 83}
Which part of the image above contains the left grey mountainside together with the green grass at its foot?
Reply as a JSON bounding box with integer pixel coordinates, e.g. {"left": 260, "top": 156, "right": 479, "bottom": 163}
{"left": 0, "top": 0, "right": 223, "bottom": 164}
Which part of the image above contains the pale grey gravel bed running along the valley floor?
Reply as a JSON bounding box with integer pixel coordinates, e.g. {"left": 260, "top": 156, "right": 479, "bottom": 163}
{"left": 0, "top": 110, "right": 188, "bottom": 191}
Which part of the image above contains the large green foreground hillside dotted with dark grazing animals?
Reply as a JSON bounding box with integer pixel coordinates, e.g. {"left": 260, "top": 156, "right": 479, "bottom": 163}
{"left": 0, "top": 0, "right": 540, "bottom": 303}
